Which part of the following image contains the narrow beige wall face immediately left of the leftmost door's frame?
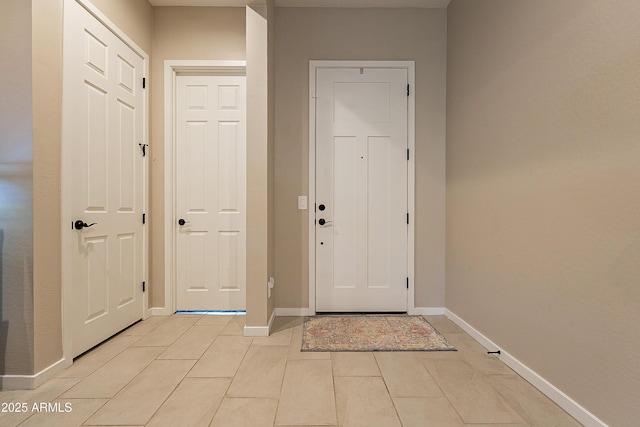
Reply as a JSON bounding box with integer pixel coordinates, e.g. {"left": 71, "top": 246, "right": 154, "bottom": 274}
{"left": 31, "top": 0, "right": 62, "bottom": 373}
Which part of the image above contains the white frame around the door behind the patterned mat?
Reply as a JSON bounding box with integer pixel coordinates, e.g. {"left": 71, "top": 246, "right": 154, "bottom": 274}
{"left": 305, "top": 61, "right": 417, "bottom": 315}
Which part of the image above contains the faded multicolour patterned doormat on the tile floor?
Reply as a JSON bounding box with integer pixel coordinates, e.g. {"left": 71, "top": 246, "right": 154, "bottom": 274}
{"left": 301, "top": 315, "right": 457, "bottom": 351}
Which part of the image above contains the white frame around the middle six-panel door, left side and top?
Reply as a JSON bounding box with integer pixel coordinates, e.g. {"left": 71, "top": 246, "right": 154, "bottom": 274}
{"left": 161, "top": 60, "right": 247, "bottom": 315}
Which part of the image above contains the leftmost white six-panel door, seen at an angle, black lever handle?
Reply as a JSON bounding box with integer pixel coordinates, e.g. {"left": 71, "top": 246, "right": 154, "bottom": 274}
{"left": 63, "top": 1, "right": 145, "bottom": 356}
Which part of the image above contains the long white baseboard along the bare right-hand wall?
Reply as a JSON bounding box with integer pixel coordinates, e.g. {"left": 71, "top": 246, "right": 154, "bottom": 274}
{"left": 444, "top": 308, "right": 608, "bottom": 427}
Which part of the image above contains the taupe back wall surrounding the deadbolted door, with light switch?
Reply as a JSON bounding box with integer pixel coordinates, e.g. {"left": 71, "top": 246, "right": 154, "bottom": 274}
{"left": 275, "top": 8, "right": 446, "bottom": 307}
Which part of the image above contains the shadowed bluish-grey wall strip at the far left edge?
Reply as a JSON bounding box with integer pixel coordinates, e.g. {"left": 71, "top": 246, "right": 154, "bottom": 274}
{"left": 0, "top": 0, "right": 33, "bottom": 378}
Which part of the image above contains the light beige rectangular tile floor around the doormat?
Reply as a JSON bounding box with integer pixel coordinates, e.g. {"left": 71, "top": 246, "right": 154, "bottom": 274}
{"left": 0, "top": 315, "right": 580, "bottom": 427}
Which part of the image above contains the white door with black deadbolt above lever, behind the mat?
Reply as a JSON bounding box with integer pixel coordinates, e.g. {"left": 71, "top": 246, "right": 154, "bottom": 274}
{"left": 316, "top": 68, "right": 408, "bottom": 312}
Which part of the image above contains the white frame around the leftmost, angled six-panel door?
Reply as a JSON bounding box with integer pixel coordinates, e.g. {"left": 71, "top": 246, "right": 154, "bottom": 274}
{"left": 61, "top": 0, "right": 149, "bottom": 366}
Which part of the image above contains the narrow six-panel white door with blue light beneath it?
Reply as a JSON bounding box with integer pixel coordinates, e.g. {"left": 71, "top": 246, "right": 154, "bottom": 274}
{"left": 175, "top": 76, "right": 246, "bottom": 310}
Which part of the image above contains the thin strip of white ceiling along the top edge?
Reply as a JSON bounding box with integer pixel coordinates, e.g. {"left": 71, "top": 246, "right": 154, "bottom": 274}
{"left": 149, "top": 0, "right": 451, "bottom": 8}
